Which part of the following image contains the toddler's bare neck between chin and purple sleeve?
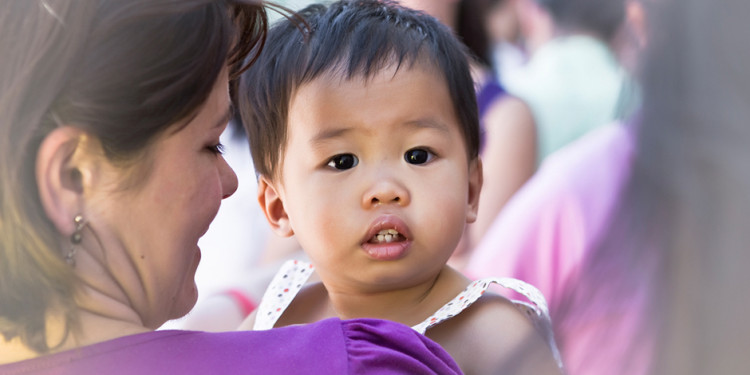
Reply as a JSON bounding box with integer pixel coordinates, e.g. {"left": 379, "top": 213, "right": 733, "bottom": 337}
{"left": 326, "top": 266, "right": 469, "bottom": 326}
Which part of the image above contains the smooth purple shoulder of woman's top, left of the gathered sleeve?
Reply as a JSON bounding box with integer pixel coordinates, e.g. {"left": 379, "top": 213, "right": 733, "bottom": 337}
{"left": 0, "top": 328, "right": 348, "bottom": 375}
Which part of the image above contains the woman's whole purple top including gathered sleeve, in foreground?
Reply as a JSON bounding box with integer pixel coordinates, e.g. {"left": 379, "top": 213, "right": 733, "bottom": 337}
{"left": 0, "top": 318, "right": 461, "bottom": 375}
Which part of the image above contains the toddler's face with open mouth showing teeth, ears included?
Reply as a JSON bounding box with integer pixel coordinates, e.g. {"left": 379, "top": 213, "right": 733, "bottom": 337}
{"left": 260, "top": 65, "right": 482, "bottom": 291}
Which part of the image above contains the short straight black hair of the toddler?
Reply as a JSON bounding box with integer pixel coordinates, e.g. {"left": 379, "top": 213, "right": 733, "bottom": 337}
{"left": 238, "top": 0, "right": 479, "bottom": 178}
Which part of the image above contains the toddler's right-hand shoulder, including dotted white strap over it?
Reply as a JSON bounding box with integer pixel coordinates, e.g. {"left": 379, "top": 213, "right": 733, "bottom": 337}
{"left": 426, "top": 278, "right": 559, "bottom": 373}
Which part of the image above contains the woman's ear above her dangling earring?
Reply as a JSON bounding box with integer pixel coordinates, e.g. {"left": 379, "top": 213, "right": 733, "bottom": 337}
{"left": 35, "top": 126, "right": 86, "bottom": 234}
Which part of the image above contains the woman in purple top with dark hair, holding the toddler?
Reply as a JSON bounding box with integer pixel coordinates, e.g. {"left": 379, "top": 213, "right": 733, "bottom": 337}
{"left": 0, "top": 0, "right": 458, "bottom": 374}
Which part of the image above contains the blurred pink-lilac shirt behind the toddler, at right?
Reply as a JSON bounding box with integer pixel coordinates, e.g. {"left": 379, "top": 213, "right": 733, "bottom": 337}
{"left": 465, "top": 124, "right": 652, "bottom": 375}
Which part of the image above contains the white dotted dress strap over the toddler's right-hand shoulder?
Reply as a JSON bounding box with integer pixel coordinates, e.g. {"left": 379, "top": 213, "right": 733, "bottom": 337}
{"left": 412, "top": 277, "right": 563, "bottom": 369}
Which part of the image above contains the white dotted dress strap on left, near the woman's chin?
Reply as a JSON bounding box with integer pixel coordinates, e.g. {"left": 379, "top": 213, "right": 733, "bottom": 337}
{"left": 253, "top": 260, "right": 313, "bottom": 331}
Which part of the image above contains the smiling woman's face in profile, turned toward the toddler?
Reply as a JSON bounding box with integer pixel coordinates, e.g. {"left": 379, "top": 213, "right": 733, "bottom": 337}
{"left": 84, "top": 73, "right": 237, "bottom": 328}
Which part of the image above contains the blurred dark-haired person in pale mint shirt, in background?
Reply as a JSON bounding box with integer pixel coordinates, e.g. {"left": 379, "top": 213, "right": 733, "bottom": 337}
{"left": 503, "top": 0, "right": 634, "bottom": 163}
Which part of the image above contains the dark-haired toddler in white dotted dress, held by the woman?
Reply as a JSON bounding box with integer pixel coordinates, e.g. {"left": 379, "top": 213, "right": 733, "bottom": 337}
{"left": 238, "top": 0, "right": 561, "bottom": 374}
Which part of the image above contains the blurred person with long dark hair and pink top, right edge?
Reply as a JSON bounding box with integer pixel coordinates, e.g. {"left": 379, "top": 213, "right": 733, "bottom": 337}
{"left": 467, "top": 0, "right": 750, "bottom": 375}
